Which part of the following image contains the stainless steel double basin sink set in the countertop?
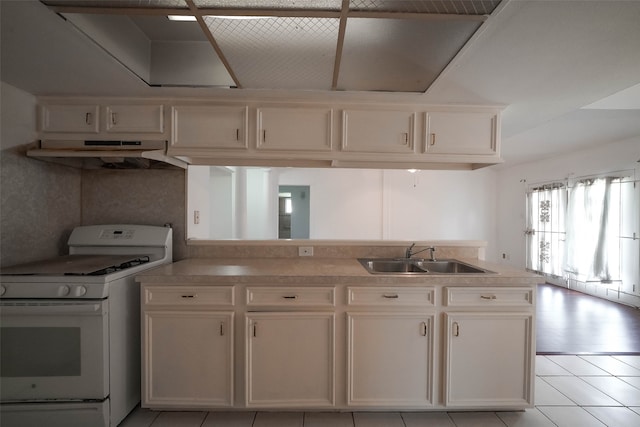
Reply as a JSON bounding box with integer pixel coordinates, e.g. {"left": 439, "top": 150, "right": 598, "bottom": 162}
{"left": 358, "top": 258, "right": 494, "bottom": 275}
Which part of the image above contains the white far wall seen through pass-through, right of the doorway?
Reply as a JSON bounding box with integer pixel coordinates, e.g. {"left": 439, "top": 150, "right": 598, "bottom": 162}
{"left": 280, "top": 169, "right": 497, "bottom": 260}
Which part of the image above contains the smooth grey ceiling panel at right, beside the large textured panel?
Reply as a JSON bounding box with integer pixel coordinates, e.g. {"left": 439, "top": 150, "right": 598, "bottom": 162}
{"left": 338, "top": 18, "right": 481, "bottom": 92}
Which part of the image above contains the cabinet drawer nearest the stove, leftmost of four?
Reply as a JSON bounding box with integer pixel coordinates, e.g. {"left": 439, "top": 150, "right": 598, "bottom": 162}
{"left": 143, "top": 286, "right": 234, "bottom": 306}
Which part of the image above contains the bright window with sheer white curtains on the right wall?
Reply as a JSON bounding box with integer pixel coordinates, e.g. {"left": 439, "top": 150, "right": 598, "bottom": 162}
{"left": 526, "top": 177, "right": 640, "bottom": 291}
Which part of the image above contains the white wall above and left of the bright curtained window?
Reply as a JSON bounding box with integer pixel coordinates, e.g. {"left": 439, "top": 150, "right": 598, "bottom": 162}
{"left": 497, "top": 137, "right": 640, "bottom": 268}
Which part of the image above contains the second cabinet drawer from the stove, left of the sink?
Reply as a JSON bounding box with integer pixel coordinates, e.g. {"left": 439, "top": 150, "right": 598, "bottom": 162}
{"left": 247, "top": 287, "right": 335, "bottom": 307}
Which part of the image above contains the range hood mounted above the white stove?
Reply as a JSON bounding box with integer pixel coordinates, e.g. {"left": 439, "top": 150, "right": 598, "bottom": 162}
{"left": 27, "top": 140, "right": 187, "bottom": 169}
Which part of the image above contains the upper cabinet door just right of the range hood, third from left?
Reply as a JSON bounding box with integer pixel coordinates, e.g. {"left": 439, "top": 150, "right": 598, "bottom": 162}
{"left": 171, "top": 106, "right": 249, "bottom": 149}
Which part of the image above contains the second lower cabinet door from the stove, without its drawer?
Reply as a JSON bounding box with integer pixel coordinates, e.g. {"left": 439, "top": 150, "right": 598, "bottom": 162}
{"left": 246, "top": 312, "right": 335, "bottom": 407}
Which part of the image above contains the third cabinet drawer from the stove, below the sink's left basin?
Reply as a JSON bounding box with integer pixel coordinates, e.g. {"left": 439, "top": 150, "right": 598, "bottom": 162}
{"left": 347, "top": 286, "right": 434, "bottom": 306}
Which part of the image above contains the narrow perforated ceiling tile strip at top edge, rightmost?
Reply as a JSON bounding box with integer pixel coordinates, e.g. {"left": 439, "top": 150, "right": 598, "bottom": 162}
{"left": 349, "top": 0, "right": 500, "bottom": 15}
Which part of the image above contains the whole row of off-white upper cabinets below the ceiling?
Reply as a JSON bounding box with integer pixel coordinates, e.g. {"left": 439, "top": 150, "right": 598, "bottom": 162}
{"left": 39, "top": 98, "right": 502, "bottom": 169}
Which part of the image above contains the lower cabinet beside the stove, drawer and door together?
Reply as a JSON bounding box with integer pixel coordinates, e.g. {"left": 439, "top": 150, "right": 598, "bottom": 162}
{"left": 141, "top": 284, "right": 235, "bottom": 409}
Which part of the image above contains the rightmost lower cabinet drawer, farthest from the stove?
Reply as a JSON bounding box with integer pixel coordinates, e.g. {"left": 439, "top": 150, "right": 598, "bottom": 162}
{"left": 444, "top": 287, "right": 535, "bottom": 307}
